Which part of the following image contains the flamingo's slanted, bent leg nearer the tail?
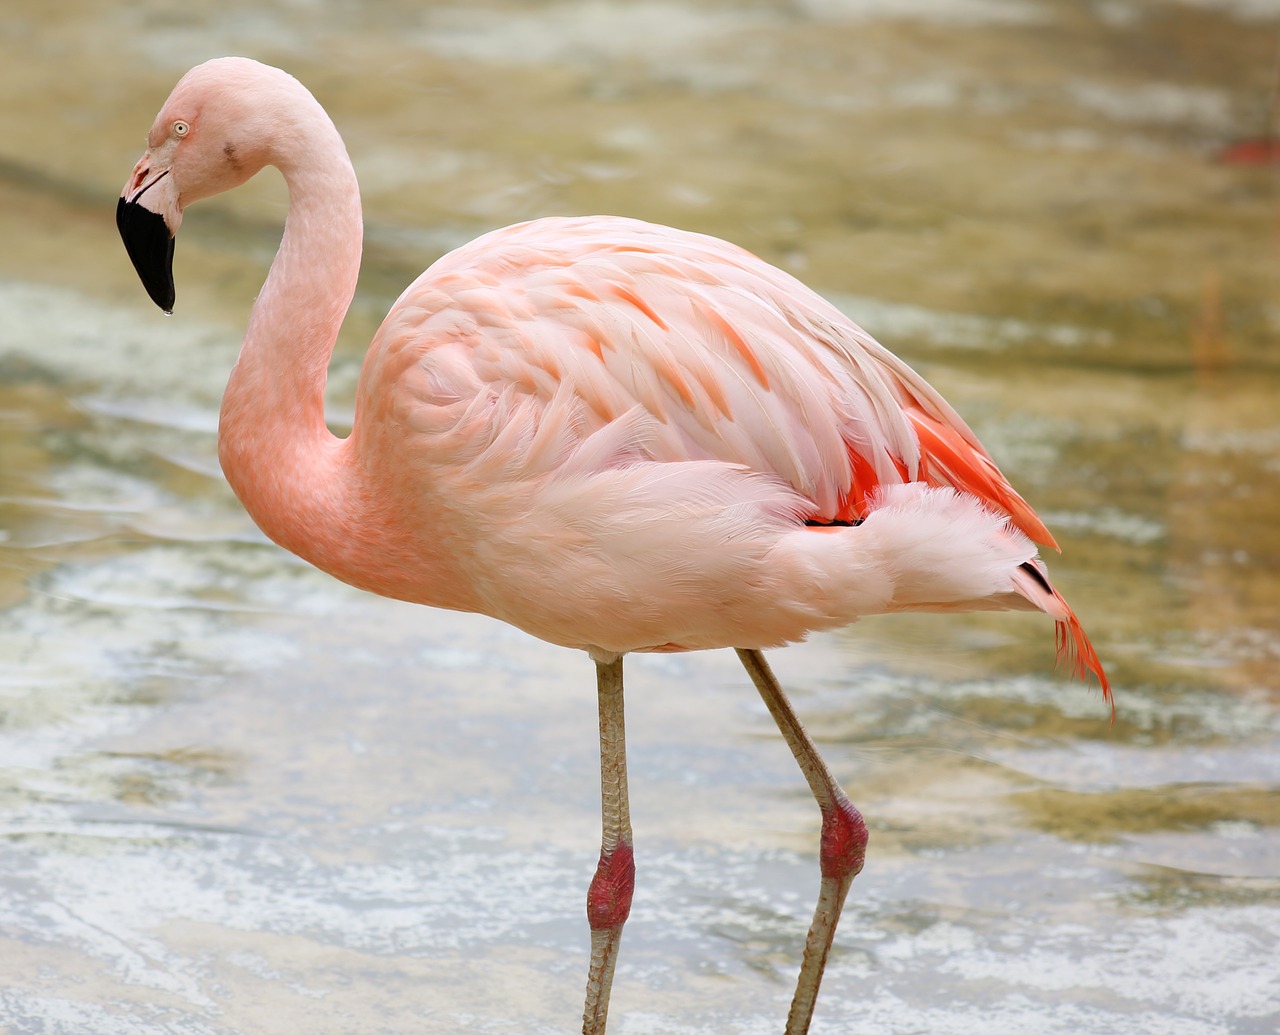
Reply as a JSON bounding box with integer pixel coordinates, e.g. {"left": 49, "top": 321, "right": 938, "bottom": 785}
{"left": 737, "top": 650, "right": 867, "bottom": 1035}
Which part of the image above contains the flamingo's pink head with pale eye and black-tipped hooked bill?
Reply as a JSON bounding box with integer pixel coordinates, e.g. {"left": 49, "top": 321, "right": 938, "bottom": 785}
{"left": 115, "top": 58, "right": 300, "bottom": 312}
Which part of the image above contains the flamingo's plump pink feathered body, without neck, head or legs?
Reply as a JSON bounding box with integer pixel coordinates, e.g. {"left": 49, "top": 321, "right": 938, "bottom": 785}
{"left": 262, "top": 207, "right": 1100, "bottom": 654}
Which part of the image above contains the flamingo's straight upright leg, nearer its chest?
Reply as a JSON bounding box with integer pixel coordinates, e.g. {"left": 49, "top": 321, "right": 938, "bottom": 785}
{"left": 582, "top": 655, "right": 636, "bottom": 1035}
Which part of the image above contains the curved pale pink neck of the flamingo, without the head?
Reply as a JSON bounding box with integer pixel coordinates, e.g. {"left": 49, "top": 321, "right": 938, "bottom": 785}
{"left": 218, "top": 111, "right": 364, "bottom": 567}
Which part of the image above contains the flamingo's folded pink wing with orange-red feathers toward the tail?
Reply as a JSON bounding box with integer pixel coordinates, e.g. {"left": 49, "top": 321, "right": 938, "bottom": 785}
{"left": 381, "top": 217, "right": 1053, "bottom": 545}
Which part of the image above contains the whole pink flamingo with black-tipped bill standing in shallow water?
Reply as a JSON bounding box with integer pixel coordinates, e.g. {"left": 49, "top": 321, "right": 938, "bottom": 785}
{"left": 116, "top": 58, "right": 1114, "bottom": 1035}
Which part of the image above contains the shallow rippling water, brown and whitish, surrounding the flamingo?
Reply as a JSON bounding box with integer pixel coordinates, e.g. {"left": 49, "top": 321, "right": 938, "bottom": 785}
{"left": 0, "top": 0, "right": 1280, "bottom": 1035}
